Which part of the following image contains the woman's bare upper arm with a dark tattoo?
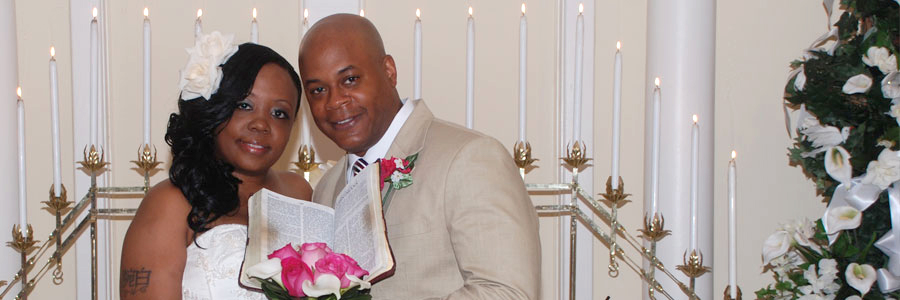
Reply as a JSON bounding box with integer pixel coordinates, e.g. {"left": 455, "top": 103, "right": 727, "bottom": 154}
{"left": 119, "top": 180, "right": 190, "bottom": 299}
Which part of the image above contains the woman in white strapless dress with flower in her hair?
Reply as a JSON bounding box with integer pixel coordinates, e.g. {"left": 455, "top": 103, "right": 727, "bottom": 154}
{"left": 119, "top": 32, "right": 312, "bottom": 299}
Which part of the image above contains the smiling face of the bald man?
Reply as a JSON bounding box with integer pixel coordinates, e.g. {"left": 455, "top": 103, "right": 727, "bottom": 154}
{"left": 300, "top": 35, "right": 400, "bottom": 156}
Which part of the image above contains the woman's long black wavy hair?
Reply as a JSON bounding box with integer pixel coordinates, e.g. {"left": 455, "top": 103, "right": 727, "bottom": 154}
{"left": 166, "top": 43, "right": 302, "bottom": 238}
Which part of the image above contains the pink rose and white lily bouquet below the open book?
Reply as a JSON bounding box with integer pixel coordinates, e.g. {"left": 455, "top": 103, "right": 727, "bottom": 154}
{"left": 247, "top": 243, "right": 372, "bottom": 300}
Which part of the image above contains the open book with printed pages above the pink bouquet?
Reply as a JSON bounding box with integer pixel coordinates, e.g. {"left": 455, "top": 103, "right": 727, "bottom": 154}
{"left": 240, "top": 163, "right": 394, "bottom": 289}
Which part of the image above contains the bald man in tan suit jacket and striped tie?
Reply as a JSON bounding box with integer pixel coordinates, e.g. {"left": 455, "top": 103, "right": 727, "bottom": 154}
{"left": 299, "top": 14, "right": 541, "bottom": 299}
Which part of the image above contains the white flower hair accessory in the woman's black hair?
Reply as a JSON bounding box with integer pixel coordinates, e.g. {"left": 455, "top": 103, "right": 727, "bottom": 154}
{"left": 178, "top": 31, "right": 238, "bottom": 100}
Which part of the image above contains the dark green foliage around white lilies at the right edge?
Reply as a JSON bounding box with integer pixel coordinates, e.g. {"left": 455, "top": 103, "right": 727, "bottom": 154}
{"left": 756, "top": 0, "right": 900, "bottom": 299}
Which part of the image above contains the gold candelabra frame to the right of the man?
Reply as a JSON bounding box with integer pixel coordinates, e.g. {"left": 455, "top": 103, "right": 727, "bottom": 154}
{"left": 513, "top": 141, "right": 712, "bottom": 299}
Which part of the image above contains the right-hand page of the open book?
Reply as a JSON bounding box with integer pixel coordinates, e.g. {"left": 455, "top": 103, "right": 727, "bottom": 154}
{"left": 332, "top": 163, "right": 393, "bottom": 276}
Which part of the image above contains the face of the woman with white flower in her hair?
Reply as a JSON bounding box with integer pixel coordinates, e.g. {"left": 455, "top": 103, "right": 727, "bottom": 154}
{"left": 216, "top": 63, "right": 298, "bottom": 176}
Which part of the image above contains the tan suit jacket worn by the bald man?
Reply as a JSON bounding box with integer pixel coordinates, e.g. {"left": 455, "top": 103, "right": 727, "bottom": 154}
{"left": 313, "top": 100, "right": 541, "bottom": 299}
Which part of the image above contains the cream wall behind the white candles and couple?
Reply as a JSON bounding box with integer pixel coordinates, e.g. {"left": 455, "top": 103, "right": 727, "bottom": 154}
{"left": 8, "top": 0, "right": 826, "bottom": 299}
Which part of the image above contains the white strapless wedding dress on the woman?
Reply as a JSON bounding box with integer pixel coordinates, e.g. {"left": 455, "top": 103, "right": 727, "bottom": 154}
{"left": 181, "top": 224, "right": 266, "bottom": 300}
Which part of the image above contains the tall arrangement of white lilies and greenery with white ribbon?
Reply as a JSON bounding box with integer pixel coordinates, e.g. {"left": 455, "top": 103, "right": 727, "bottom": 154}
{"left": 756, "top": 0, "right": 900, "bottom": 299}
